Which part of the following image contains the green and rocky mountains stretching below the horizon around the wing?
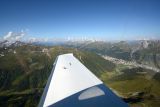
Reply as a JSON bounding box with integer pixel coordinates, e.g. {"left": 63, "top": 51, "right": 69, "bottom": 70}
{"left": 0, "top": 41, "right": 160, "bottom": 107}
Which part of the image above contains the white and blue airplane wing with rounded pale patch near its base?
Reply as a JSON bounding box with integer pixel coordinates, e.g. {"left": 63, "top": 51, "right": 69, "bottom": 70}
{"left": 39, "top": 54, "right": 128, "bottom": 107}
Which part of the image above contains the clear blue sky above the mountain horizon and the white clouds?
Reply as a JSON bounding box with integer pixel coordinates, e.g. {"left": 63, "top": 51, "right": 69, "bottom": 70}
{"left": 0, "top": 0, "right": 160, "bottom": 40}
